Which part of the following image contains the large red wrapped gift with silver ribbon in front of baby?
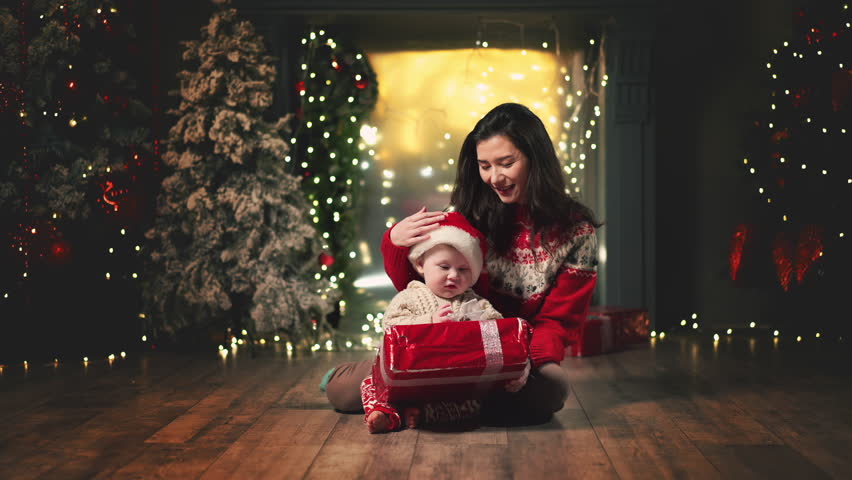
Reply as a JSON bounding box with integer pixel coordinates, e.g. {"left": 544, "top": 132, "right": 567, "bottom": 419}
{"left": 373, "top": 318, "right": 532, "bottom": 403}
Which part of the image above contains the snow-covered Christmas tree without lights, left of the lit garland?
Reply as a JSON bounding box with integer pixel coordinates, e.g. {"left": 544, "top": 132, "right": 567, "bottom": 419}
{"left": 145, "top": 0, "right": 337, "bottom": 343}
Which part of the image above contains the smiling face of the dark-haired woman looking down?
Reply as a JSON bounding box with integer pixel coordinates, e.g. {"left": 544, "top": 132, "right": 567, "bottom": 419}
{"left": 476, "top": 135, "right": 530, "bottom": 204}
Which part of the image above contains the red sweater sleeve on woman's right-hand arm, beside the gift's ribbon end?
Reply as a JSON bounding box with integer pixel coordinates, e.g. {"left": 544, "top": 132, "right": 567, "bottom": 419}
{"left": 530, "top": 228, "right": 597, "bottom": 366}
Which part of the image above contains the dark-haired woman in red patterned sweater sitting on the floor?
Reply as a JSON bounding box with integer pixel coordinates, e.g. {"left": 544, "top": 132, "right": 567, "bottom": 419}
{"left": 323, "top": 103, "right": 600, "bottom": 421}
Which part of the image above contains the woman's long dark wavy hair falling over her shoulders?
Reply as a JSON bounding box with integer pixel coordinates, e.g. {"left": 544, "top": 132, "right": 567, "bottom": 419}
{"left": 450, "top": 103, "right": 602, "bottom": 254}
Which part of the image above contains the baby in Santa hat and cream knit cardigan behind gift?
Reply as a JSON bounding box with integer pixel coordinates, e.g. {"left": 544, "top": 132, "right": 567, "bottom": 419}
{"left": 361, "top": 212, "right": 526, "bottom": 433}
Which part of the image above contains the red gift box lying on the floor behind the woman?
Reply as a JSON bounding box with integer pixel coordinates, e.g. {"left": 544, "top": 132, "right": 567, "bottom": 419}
{"left": 568, "top": 305, "right": 651, "bottom": 357}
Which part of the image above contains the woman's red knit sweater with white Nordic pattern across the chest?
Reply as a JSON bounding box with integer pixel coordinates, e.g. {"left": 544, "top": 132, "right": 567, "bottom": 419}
{"left": 381, "top": 209, "right": 597, "bottom": 366}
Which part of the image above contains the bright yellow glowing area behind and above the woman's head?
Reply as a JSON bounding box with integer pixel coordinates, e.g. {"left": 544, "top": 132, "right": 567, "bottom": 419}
{"left": 370, "top": 48, "right": 564, "bottom": 160}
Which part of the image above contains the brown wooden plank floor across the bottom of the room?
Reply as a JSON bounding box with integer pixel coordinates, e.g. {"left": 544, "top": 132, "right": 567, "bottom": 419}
{"left": 0, "top": 337, "right": 852, "bottom": 480}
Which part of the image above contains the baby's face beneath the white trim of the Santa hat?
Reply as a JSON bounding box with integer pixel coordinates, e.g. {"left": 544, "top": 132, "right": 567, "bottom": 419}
{"left": 417, "top": 245, "right": 476, "bottom": 299}
